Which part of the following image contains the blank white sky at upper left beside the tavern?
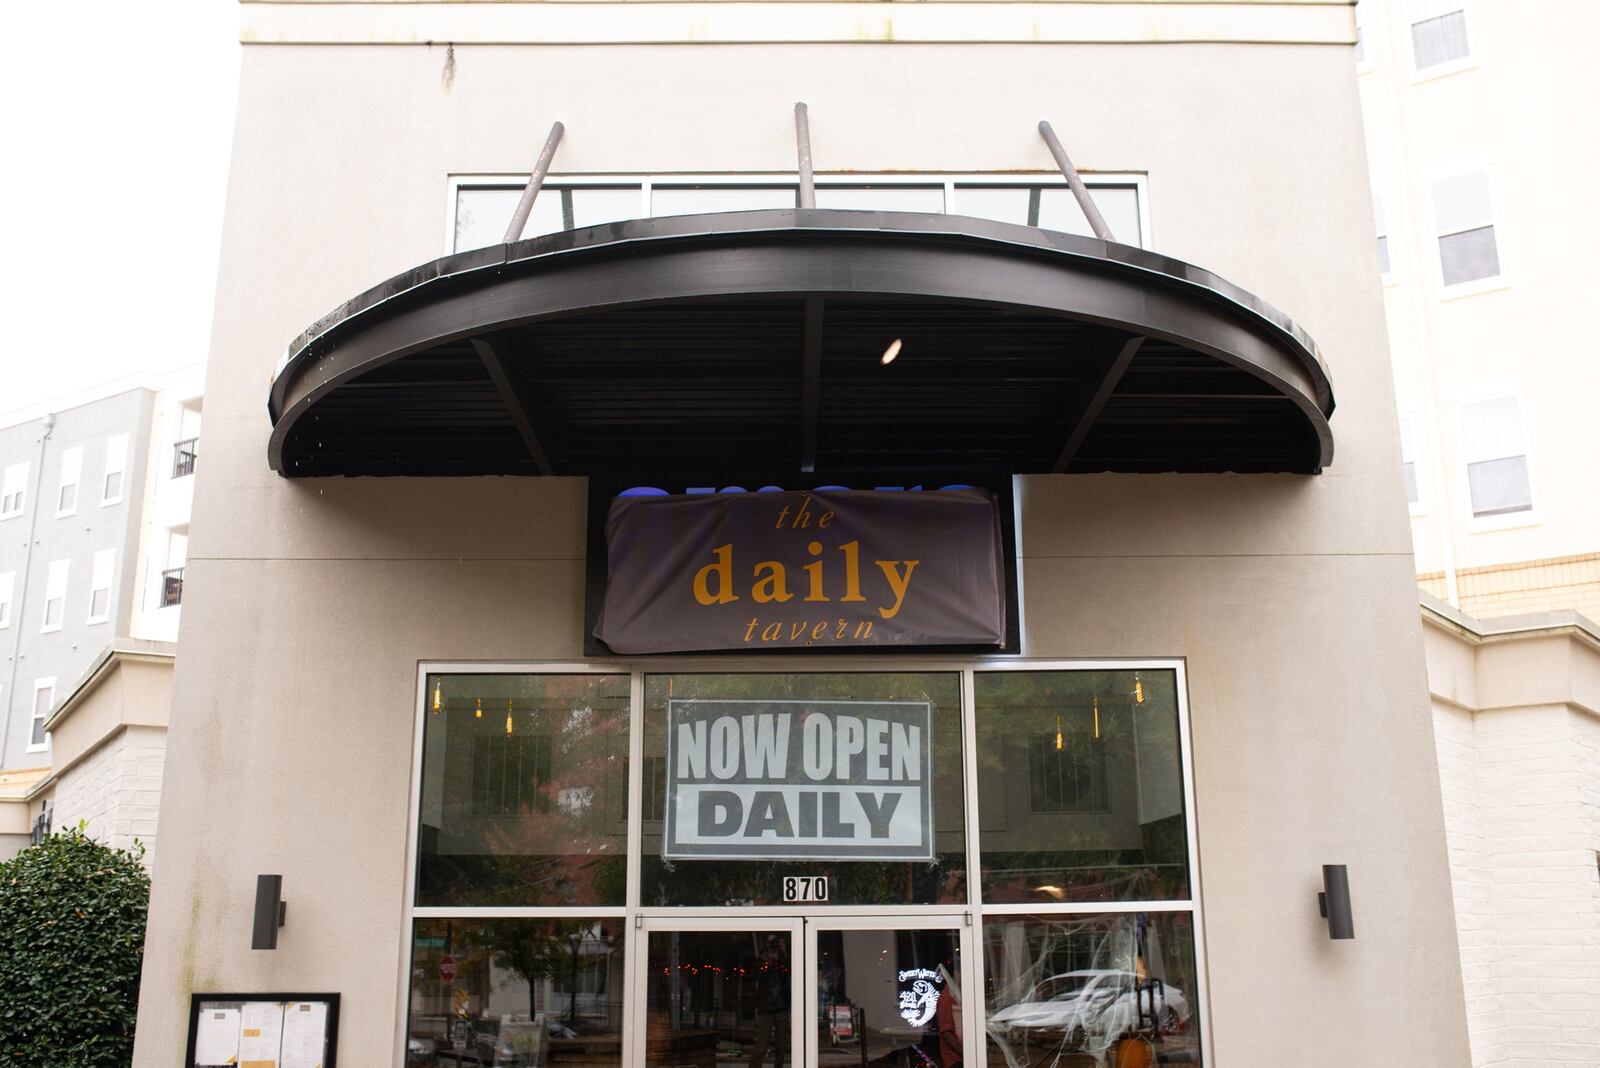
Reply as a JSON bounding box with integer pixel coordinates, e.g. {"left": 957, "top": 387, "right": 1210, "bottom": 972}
{"left": 0, "top": 0, "right": 238, "bottom": 416}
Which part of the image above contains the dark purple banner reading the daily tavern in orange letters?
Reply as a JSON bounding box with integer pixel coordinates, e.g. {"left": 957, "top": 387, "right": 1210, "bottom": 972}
{"left": 595, "top": 489, "right": 1005, "bottom": 654}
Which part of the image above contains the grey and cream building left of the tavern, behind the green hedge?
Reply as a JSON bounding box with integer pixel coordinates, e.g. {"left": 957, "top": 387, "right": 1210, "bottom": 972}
{"left": 0, "top": 368, "right": 202, "bottom": 857}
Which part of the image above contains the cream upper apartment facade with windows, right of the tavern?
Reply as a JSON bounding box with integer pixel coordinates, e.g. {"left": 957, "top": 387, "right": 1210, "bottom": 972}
{"left": 1357, "top": 0, "right": 1600, "bottom": 619}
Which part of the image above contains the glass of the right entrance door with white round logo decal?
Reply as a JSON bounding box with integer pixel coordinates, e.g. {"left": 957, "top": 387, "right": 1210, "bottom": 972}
{"left": 814, "top": 931, "right": 962, "bottom": 1068}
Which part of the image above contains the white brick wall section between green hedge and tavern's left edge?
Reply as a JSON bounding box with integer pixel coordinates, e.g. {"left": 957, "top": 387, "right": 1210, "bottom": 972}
{"left": 51, "top": 727, "right": 166, "bottom": 865}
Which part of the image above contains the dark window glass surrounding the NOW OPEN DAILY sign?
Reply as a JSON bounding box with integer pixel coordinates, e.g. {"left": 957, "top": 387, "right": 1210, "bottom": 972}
{"left": 640, "top": 671, "right": 966, "bottom": 905}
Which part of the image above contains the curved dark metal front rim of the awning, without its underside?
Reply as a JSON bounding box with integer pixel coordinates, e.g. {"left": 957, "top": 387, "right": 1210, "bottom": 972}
{"left": 269, "top": 208, "right": 1333, "bottom": 472}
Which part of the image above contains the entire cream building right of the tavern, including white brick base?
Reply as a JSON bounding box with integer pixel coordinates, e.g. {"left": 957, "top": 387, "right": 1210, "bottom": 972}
{"left": 1355, "top": 0, "right": 1600, "bottom": 1068}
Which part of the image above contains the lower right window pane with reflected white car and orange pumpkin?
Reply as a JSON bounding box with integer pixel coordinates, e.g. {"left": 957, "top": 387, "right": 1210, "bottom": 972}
{"left": 984, "top": 913, "right": 1200, "bottom": 1068}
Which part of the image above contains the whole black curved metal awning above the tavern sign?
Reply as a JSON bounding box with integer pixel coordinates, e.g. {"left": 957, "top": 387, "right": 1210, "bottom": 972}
{"left": 269, "top": 209, "right": 1333, "bottom": 476}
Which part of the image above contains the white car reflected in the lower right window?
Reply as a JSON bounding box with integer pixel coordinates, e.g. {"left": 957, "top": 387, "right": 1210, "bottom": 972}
{"left": 989, "top": 969, "right": 1189, "bottom": 1052}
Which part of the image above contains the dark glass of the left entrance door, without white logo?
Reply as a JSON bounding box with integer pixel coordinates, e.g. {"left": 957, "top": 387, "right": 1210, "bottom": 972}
{"left": 645, "top": 931, "right": 797, "bottom": 1068}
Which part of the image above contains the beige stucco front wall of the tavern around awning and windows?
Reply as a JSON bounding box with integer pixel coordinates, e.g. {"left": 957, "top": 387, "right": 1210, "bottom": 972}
{"left": 134, "top": 10, "right": 1467, "bottom": 1068}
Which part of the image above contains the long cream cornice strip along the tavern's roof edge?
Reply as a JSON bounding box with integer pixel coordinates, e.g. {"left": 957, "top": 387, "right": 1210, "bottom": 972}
{"left": 240, "top": 0, "right": 1355, "bottom": 46}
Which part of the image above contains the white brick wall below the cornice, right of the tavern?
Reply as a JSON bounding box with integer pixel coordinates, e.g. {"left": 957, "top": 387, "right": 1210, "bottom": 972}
{"left": 1434, "top": 703, "right": 1600, "bottom": 1068}
